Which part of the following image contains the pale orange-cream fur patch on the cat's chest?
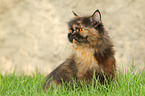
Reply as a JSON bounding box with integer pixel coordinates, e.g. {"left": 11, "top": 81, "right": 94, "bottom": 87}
{"left": 75, "top": 47, "right": 99, "bottom": 70}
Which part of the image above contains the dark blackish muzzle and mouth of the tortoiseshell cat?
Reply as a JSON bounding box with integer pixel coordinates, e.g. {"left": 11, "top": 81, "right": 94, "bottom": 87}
{"left": 68, "top": 33, "right": 88, "bottom": 43}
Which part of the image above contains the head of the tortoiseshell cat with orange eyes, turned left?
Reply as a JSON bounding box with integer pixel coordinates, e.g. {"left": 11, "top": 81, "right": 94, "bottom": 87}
{"left": 68, "top": 10, "right": 105, "bottom": 46}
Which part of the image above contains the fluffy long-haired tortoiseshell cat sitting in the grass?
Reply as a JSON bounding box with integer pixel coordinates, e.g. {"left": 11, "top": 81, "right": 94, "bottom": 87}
{"left": 43, "top": 10, "right": 116, "bottom": 90}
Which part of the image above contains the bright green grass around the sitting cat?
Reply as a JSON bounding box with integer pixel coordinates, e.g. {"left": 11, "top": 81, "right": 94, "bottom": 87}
{"left": 0, "top": 71, "right": 145, "bottom": 96}
